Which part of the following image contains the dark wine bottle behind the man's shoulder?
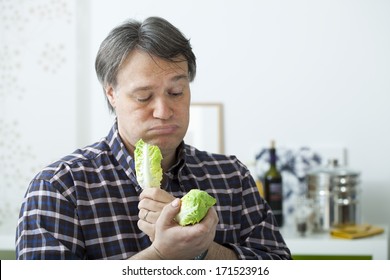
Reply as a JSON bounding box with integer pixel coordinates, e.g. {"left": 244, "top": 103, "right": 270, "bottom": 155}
{"left": 263, "top": 140, "right": 283, "bottom": 227}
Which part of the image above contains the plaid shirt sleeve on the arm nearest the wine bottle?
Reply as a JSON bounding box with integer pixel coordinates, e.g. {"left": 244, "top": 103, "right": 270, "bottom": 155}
{"left": 224, "top": 159, "right": 291, "bottom": 260}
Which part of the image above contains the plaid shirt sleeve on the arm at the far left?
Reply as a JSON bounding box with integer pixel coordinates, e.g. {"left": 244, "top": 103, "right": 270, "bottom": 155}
{"left": 16, "top": 175, "right": 85, "bottom": 260}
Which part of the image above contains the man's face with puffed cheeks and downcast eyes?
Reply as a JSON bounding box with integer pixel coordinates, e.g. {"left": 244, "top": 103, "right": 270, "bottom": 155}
{"left": 106, "top": 51, "right": 191, "bottom": 155}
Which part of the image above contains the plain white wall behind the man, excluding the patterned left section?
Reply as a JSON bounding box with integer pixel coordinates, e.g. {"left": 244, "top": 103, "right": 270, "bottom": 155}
{"left": 84, "top": 0, "right": 390, "bottom": 230}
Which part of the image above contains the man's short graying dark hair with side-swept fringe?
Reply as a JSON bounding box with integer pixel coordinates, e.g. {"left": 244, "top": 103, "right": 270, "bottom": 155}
{"left": 95, "top": 17, "right": 196, "bottom": 112}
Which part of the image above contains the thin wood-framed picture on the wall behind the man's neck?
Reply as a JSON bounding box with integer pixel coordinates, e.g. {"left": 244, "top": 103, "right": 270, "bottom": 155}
{"left": 184, "top": 103, "right": 224, "bottom": 154}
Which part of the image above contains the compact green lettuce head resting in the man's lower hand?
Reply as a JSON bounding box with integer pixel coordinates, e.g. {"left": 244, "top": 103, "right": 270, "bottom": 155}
{"left": 175, "top": 189, "right": 217, "bottom": 226}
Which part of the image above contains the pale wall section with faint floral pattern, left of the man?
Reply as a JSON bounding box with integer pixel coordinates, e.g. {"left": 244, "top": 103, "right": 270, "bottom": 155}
{"left": 0, "top": 0, "right": 76, "bottom": 235}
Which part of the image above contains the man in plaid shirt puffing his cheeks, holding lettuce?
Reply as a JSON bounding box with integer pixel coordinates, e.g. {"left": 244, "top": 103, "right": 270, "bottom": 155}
{"left": 16, "top": 17, "right": 291, "bottom": 259}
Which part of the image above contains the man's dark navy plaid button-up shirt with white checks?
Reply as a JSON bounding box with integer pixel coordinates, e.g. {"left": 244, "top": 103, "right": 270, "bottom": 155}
{"left": 16, "top": 124, "right": 291, "bottom": 259}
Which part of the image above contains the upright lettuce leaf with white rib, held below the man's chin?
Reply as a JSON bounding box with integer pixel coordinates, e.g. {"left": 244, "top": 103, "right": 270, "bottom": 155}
{"left": 134, "top": 139, "right": 163, "bottom": 189}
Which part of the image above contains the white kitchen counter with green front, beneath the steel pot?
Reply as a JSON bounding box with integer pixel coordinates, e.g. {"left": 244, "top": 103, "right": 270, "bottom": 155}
{"left": 281, "top": 226, "right": 389, "bottom": 260}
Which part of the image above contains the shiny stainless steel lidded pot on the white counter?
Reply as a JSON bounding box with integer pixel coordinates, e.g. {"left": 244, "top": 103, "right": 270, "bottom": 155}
{"left": 306, "top": 160, "right": 360, "bottom": 232}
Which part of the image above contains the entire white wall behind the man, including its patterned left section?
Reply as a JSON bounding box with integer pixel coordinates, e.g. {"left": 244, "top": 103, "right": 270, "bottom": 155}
{"left": 0, "top": 0, "right": 390, "bottom": 258}
